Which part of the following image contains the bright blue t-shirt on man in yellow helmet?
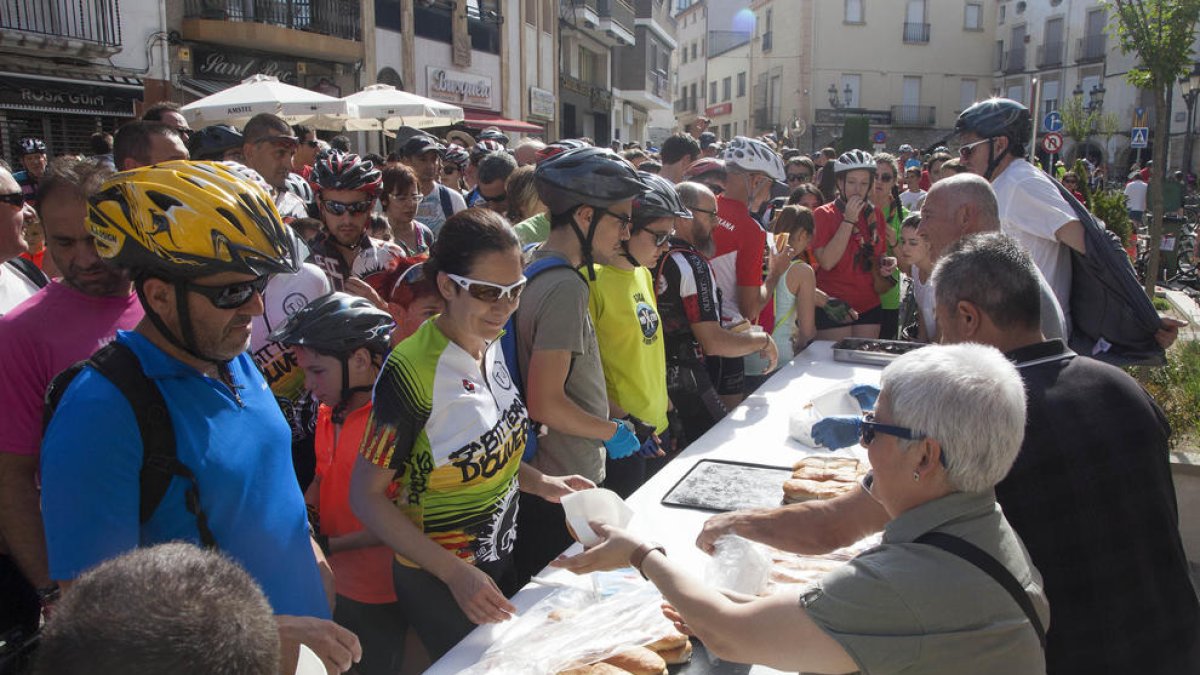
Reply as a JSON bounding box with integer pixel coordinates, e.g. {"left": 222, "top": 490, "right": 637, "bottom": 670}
{"left": 41, "top": 330, "right": 330, "bottom": 619}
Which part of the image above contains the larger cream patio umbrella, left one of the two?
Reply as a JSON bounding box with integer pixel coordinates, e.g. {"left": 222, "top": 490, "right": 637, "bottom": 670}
{"left": 180, "top": 74, "right": 347, "bottom": 130}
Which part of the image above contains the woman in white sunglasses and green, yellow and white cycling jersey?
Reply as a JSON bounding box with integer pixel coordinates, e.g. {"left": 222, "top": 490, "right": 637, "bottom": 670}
{"left": 350, "top": 209, "right": 592, "bottom": 659}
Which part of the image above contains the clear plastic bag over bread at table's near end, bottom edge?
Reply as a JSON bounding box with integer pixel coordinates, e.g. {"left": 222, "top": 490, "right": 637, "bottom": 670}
{"left": 463, "top": 569, "right": 674, "bottom": 675}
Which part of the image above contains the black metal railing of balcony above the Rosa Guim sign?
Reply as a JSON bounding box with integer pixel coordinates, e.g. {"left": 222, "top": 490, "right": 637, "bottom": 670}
{"left": 0, "top": 0, "right": 121, "bottom": 47}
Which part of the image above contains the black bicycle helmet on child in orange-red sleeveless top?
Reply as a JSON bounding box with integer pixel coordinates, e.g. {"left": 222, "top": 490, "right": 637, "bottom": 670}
{"left": 268, "top": 293, "right": 396, "bottom": 424}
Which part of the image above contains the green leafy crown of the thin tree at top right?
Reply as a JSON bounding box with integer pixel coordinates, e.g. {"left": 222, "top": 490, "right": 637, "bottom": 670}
{"left": 1105, "top": 0, "right": 1200, "bottom": 89}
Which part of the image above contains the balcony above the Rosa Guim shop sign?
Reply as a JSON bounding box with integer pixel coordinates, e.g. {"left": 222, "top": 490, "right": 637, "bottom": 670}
{"left": 0, "top": 0, "right": 121, "bottom": 56}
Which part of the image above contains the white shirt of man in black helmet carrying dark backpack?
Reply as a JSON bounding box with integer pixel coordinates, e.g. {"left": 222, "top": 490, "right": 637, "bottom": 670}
{"left": 991, "top": 160, "right": 1079, "bottom": 317}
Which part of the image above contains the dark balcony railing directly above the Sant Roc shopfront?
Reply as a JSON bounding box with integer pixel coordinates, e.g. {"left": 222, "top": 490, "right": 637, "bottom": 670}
{"left": 184, "top": 0, "right": 362, "bottom": 40}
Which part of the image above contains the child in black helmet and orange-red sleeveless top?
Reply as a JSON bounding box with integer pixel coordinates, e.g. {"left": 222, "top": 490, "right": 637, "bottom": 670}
{"left": 270, "top": 293, "right": 408, "bottom": 675}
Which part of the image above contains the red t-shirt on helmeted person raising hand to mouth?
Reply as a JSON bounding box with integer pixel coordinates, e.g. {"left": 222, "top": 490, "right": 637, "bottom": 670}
{"left": 812, "top": 202, "right": 884, "bottom": 313}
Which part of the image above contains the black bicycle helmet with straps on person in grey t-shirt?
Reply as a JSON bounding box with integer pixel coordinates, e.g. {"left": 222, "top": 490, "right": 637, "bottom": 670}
{"left": 533, "top": 147, "right": 649, "bottom": 280}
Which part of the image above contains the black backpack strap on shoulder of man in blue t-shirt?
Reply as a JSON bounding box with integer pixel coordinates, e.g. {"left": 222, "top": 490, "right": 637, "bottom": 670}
{"left": 43, "top": 341, "right": 217, "bottom": 549}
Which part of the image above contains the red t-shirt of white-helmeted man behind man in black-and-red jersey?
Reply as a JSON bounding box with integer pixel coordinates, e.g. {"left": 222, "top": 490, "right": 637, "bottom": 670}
{"left": 708, "top": 195, "right": 767, "bottom": 325}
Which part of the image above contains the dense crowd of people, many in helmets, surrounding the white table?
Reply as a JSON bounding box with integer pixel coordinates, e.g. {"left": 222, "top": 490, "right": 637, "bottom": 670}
{"left": 0, "top": 98, "right": 1200, "bottom": 675}
